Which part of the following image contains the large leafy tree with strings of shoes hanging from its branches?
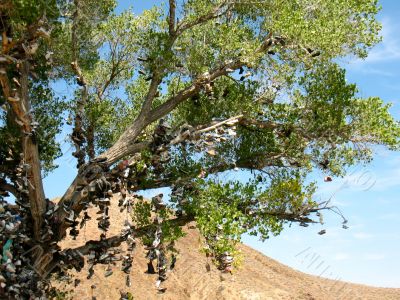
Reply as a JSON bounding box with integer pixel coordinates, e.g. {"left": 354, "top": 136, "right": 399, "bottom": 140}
{"left": 0, "top": 0, "right": 400, "bottom": 298}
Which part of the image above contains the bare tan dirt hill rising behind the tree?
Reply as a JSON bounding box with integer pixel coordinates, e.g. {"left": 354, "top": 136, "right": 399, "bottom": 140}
{"left": 55, "top": 201, "right": 400, "bottom": 300}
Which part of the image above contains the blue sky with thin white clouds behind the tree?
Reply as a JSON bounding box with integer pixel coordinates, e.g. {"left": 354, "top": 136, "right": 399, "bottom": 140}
{"left": 45, "top": 0, "right": 400, "bottom": 287}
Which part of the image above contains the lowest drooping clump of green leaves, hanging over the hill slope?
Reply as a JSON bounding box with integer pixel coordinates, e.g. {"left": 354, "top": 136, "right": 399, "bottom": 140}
{"left": 184, "top": 173, "right": 317, "bottom": 256}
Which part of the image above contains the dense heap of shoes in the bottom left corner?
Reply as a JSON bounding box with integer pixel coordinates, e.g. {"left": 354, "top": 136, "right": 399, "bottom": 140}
{"left": 0, "top": 197, "right": 44, "bottom": 299}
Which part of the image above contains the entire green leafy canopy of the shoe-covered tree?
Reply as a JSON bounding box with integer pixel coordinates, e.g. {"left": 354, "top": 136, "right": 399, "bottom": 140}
{"left": 0, "top": 0, "right": 400, "bottom": 274}
